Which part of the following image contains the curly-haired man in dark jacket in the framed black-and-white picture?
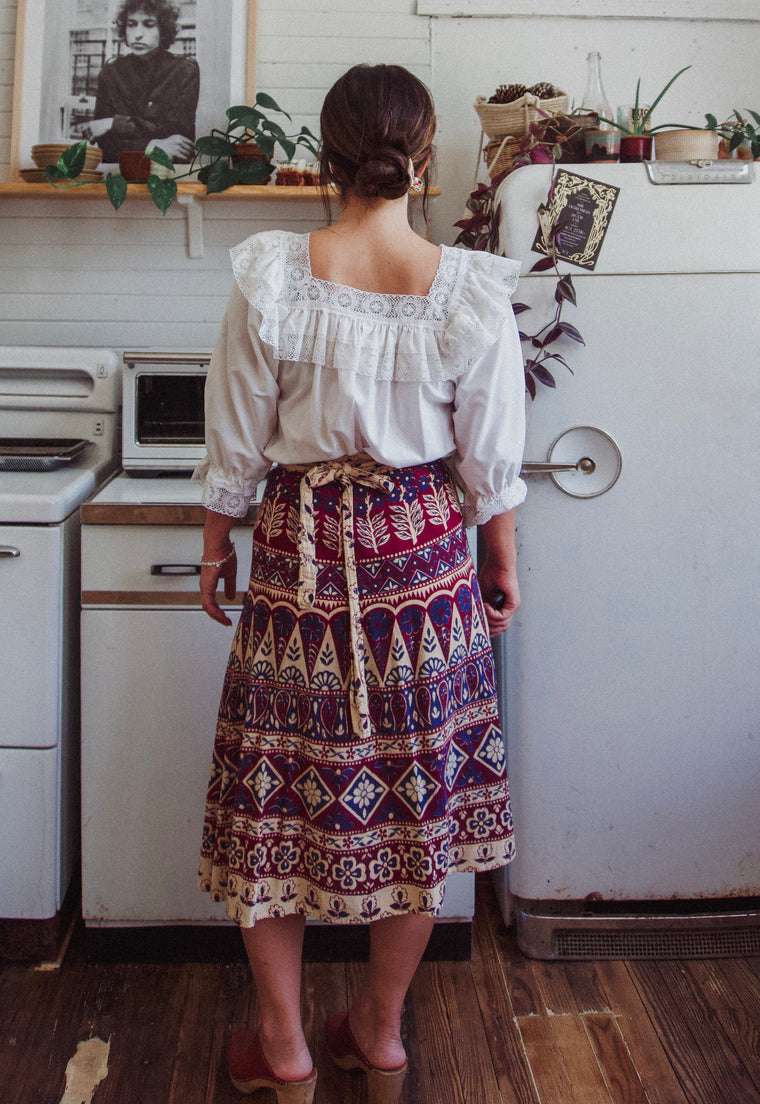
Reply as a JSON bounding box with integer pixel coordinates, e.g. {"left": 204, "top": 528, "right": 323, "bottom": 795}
{"left": 82, "top": 0, "right": 200, "bottom": 162}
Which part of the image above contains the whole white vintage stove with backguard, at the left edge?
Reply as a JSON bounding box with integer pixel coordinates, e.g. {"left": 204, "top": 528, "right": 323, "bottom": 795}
{"left": 0, "top": 347, "right": 120, "bottom": 940}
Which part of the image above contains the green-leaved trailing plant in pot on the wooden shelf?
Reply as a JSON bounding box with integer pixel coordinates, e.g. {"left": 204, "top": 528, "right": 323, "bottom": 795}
{"left": 45, "top": 92, "right": 318, "bottom": 214}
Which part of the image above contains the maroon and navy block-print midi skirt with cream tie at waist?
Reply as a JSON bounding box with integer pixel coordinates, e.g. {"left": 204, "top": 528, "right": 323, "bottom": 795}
{"left": 199, "top": 457, "right": 514, "bottom": 927}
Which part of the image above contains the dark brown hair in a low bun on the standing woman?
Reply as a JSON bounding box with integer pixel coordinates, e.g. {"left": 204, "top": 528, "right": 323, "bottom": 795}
{"left": 319, "top": 65, "right": 435, "bottom": 215}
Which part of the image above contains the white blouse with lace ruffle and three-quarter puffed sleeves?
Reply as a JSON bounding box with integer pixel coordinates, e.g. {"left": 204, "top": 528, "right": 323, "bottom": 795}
{"left": 192, "top": 231, "right": 526, "bottom": 524}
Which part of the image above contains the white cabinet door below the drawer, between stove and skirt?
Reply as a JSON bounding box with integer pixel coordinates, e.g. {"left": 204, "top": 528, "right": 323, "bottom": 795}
{"left": 82, "top": 604, "right": 233, "bottom": 924}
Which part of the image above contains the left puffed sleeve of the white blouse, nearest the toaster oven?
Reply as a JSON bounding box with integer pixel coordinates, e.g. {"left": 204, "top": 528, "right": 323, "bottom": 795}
{"left": 192, "top": 276, "right": 279, "bottom": 518}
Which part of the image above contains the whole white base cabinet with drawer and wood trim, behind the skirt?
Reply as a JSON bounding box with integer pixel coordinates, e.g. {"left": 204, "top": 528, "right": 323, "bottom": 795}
{"left": 82, "top": 480, "right": 474, "bottom": 926}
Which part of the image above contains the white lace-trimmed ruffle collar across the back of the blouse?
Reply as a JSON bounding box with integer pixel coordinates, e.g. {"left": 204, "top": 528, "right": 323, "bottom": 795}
{"left": 231, "top": 231, "right": 519, "bottom": 380}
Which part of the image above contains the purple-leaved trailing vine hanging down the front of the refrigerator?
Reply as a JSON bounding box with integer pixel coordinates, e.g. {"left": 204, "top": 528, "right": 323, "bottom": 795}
{"left": 454, "top": 116, "right": 585, "bottom": 399}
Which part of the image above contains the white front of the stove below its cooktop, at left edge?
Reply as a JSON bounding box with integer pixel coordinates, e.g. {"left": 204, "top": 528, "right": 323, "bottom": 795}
{"left": 0, "top": 511, "right": 80, "bottom": 920}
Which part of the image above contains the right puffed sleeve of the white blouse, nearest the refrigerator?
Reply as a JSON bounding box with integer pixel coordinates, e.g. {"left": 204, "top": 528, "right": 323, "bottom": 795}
{"left": 453, "top": 254, "right": 527, "bottom": 526}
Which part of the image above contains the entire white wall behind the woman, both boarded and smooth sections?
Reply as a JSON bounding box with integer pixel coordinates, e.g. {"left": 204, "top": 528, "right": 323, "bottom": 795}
{"left": 0, "top": 0, "right": 760, "bottom": 350}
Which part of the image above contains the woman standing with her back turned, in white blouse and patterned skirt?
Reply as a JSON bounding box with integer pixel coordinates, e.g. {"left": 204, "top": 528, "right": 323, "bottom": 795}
{"left": 194, "top": 65, "right": 525, "bottom": 1104}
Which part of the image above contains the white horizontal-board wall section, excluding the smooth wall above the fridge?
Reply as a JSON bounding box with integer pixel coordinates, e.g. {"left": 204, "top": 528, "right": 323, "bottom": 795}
{"left": 0, "top": 0, "right": 431, "bottom": 350}
